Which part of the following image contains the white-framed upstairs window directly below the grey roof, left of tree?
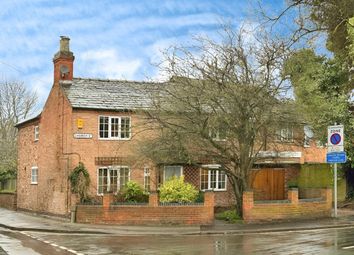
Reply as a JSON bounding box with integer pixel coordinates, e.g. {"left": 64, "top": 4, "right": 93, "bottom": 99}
{"left": 99, "top": 116, "right": 131, "bottom": 140}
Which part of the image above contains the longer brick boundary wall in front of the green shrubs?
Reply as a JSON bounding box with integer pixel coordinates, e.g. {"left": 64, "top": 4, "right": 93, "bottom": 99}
{"left": 76, "top": 192, "right": 215, "bottom": 225}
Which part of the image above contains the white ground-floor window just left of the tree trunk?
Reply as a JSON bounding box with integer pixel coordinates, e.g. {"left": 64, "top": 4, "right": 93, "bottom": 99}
{"left": 200, "top": 169, "right": 227, "bottom": 191}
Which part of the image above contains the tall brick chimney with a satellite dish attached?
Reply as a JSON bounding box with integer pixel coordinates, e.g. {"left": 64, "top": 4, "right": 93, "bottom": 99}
{"left": 53, "top": 36, "right": 75, "bottom": 84}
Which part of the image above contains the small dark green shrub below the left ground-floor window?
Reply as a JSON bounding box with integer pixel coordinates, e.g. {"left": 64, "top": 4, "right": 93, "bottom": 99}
{"left": 117, "top": 181, "right": 149, "bottom": 203}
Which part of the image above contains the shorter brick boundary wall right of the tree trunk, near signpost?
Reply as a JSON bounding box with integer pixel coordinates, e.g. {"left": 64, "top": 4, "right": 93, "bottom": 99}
{"left": 243, "top": 189, "right": 332, "bottom": 222}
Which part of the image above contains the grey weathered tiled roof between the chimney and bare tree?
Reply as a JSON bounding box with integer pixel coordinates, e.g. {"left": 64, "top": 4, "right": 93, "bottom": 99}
{"left": 61, "top": 78, "right": 164, "bottom": 110}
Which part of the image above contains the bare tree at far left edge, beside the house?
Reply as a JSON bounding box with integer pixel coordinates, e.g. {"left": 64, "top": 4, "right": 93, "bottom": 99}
{"left": 0, "top": 81, "right": 37, "bottom": 179}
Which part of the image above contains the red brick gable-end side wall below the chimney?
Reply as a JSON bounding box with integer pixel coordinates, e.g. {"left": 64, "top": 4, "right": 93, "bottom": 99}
{"left": 17, "top": 84, "right": 72, "bottom": 215}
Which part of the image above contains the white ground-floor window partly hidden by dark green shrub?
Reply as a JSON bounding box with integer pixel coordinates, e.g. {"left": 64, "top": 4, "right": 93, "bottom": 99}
{"left": 97, "top": 166, "right": 130, "bottom": 195}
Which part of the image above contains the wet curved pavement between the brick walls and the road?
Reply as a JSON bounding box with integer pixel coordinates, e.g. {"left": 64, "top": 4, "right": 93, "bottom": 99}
{"left": 0, "top": 208, "right": 354, "bottom": 236}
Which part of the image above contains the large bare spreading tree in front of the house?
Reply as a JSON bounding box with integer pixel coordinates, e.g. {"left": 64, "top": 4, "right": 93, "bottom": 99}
{"left": 142, "top": 26, "right": 298, "bottom": 215}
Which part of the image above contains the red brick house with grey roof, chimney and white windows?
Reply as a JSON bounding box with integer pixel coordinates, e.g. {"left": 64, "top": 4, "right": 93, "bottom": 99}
{"left": 17, "top": 37, "right": 325, "bottom": 215}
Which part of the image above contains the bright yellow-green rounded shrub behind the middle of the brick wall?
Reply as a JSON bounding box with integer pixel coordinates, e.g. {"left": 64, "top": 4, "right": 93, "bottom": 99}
{"left": 160, "top": 176, "right": 199, "bottom": 203}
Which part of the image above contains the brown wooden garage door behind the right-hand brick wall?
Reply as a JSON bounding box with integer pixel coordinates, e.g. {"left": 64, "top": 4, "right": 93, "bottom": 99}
{"left": 252, "top": 169, "right": 285, "bottom": 200}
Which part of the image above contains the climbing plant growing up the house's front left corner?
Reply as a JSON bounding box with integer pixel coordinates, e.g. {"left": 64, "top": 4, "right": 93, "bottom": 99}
{"left": 69, "top": 162, "right": 90, "bottom": 202}
